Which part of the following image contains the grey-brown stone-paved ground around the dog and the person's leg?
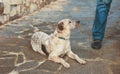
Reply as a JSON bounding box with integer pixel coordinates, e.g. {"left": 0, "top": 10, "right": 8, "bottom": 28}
{"left": 0, "top": 0, "right": 120, "bottom": 74}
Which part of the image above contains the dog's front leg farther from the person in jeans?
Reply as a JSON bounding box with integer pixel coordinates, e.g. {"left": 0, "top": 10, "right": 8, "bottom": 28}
{"left": 48, "top": 56, "right": 70, "bottom": 68}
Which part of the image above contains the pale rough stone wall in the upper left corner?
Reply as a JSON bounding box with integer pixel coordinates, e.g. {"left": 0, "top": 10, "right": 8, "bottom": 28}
{"left": 0, "top": 0, "right": 55, "bottom": 25}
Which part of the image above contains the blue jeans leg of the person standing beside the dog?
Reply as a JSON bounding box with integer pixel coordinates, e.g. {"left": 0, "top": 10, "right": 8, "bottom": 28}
{"left": 92, "top": 0, "right": 112, "bottom": 40}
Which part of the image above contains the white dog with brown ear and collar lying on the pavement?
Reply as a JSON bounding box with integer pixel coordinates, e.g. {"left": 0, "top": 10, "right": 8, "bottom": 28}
{"left": 31, "top": 19, "right": 86, "bottom": 68}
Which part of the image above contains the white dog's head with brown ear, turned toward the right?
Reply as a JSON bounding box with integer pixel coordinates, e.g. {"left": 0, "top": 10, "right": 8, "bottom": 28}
{"left": 57, "top": 19, "right": 80, "bottom": 31}
